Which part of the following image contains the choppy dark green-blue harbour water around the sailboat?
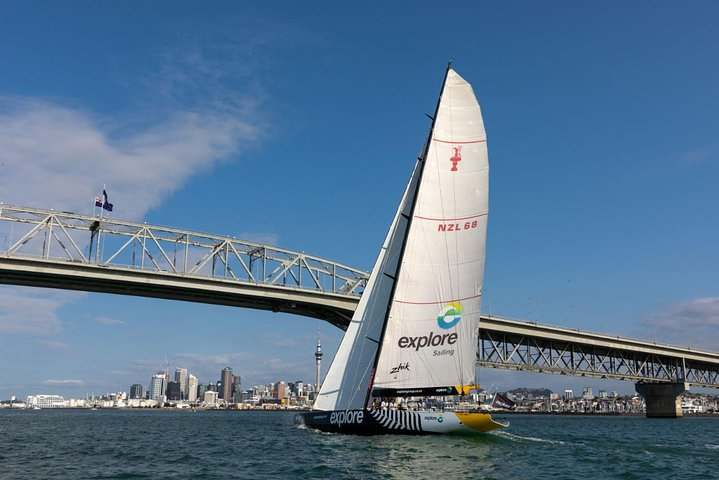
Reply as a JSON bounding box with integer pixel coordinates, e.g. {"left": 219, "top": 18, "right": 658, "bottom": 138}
{"left": 0, "top": 410, "right": 719, "bottom": 480}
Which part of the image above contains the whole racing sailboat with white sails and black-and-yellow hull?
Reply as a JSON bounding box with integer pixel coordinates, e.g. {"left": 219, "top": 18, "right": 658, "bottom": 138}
{"left": 301, "top": 64, "right": 505, "bottom": 435}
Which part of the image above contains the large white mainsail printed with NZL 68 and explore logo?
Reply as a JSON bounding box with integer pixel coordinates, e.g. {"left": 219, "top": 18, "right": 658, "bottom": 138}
{"left": 374, "top": 69, "right": 489, "bottom": 390}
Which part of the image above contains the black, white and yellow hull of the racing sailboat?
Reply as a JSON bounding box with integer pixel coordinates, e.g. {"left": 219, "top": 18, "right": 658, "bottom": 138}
{"left": 298, "top": 410, "right": 507, "bottom": 435}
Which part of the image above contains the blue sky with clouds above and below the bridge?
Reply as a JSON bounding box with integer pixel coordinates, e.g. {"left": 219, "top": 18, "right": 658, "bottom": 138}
{"left": 0, "top": 1, "right": 719, "bottom": 398}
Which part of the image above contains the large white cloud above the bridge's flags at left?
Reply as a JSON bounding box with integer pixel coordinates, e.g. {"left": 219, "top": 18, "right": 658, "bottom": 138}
{"left": 0, "top": 98, "right": 258, "bottom": 219}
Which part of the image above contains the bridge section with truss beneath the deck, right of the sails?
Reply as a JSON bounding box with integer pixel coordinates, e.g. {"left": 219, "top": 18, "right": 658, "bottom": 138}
{"left": 477, "top": 316, "right": 719, "bottom": 388}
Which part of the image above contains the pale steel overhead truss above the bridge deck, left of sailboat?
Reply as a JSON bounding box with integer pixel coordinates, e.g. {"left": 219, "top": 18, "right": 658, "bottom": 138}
{"left": 0, "top": 204, "right": 368, "bottom": 296}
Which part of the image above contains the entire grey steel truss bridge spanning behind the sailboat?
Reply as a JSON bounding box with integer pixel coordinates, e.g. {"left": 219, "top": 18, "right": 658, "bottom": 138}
{"left": 0, "top": 204, "right": 719, "bottom": 388}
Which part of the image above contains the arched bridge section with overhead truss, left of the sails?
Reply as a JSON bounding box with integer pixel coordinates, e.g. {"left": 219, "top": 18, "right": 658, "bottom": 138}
{"left": 0, "top": 204, "right": 367, "bottom": 328}
